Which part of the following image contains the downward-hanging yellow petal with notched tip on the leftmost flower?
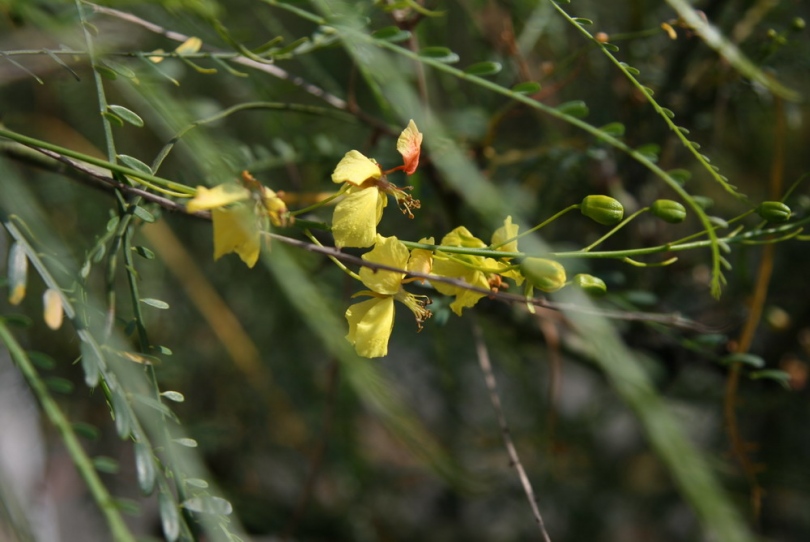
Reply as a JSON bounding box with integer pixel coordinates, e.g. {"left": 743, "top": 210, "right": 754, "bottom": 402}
{"left": 211, "top": 206, "right": 261, "bottom": 267}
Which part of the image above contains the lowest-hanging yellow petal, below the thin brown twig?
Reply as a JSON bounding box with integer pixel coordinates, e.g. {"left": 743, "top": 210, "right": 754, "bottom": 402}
{"left": 346, "top": 297, "right": 394, "bottom": 358}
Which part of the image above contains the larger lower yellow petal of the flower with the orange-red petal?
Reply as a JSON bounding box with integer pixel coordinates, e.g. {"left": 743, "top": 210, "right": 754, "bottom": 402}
{"left": 332, "top": 186, "right": 388, "bottom": 248}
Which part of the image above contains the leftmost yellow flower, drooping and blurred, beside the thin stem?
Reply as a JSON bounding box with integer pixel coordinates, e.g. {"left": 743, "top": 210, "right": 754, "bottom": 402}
{"left": 186, "top": 172, "right": 288, "bottom": 267}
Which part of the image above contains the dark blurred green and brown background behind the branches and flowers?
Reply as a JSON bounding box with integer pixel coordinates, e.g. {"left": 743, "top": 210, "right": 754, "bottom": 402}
{"left": 0, "top": 0, "right": 810, "bottom": 542}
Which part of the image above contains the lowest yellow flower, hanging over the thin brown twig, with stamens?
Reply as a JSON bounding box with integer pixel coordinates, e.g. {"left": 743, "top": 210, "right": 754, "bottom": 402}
{"left": 346, "top": 235, "right": 430, "bottom": 358}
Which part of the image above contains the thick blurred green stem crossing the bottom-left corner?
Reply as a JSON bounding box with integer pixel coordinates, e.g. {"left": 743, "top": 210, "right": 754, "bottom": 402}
{"left": 0, "top": 318, "right": 135, "bottom": 542}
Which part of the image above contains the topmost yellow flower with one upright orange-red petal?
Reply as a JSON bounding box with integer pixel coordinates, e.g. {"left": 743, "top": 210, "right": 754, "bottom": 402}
{"left": 332, "top": 121, "right": 422, "bottom": 248}
